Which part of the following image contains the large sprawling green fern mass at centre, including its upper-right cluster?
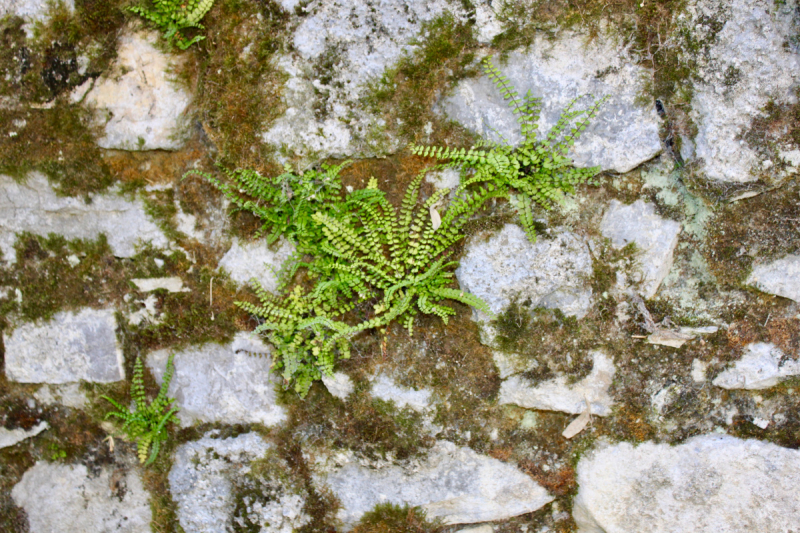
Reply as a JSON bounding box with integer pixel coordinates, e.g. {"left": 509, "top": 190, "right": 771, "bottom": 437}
{"left": 200, "top": 60, "right": 602, "bottom": 396}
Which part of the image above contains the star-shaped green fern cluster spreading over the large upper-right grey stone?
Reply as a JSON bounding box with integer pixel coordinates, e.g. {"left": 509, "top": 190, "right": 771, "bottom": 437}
{"left": 411, "top": 58, "right": 606, "bottom": 241}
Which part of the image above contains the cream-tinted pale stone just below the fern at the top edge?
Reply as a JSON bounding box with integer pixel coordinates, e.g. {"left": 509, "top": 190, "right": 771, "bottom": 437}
{"left": 73, "top": 32, "right": 191, "bottom": 150}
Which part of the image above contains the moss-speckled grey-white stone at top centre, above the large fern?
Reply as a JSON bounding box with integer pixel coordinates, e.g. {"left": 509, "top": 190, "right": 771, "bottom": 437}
{"left": 263, "top": 0, "right": 462, "bottom": 159}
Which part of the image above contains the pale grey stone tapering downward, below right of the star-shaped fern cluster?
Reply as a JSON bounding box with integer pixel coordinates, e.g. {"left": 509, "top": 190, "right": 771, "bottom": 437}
{"left": 600, "top": 200, "right": 681, "bottom": 299}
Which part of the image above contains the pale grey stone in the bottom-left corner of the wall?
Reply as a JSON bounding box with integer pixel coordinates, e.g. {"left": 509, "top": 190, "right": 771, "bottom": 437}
{"left": 11, "top": 461, "right": 152, "bottom": 533}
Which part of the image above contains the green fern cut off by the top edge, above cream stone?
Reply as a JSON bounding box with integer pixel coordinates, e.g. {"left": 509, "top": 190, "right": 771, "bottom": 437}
{"left": 128, "top": 0, "right": 214, "bottom": 50}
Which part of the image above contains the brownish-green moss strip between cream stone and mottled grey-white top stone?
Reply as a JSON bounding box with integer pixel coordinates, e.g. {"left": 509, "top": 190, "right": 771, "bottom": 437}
{"left": 180, "top": 0, "right": 289, "bottom": 173}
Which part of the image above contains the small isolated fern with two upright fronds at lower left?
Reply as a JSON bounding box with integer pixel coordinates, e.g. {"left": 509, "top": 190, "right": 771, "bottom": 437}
{"left": 102, "top": 355, "right": 178, "bottom": 465}
